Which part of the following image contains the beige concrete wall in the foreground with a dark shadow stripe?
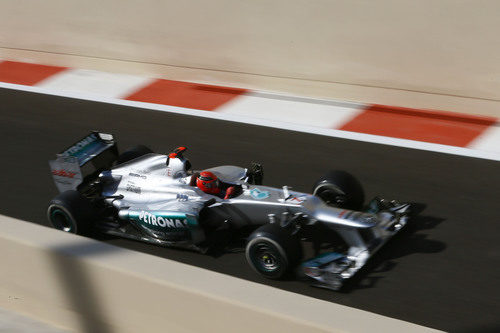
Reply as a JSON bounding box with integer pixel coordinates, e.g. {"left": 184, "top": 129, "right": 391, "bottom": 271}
{"left": 0, "top": 215, "right": 438, "bottom": 332}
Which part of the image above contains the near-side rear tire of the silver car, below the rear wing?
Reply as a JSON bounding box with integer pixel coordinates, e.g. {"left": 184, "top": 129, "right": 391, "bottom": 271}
{"left": 47, "top": 191, "right": 97, "bottom": 236}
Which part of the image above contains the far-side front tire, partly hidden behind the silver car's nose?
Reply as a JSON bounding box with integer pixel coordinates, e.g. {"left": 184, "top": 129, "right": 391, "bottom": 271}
{"left": 313, "top": 171, "right": 365, "bottom": 210}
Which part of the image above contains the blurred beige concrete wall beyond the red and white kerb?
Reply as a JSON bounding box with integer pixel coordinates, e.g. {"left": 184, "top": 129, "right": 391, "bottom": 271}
{"left": 0, "top": 0, "right": 500, "bottom": 107}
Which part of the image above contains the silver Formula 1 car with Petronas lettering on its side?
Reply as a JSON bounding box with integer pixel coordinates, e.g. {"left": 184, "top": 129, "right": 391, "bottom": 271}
{"left": 47, "top": 132, "right": 410, "bottom": 290}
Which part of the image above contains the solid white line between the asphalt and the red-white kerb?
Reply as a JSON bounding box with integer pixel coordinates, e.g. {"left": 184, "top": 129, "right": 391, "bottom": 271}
{"left": 0, "top": 82, "right": 500, "bottom": 161}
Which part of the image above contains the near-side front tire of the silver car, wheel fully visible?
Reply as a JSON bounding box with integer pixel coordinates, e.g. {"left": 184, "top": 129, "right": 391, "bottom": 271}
{"left": 245, "top": 223, "right": 302, "bottom": 279}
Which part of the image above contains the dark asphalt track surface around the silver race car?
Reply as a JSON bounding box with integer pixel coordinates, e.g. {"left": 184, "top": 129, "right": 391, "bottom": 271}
{"left": 0, "top": 89, "right": 500, "bottom": 332}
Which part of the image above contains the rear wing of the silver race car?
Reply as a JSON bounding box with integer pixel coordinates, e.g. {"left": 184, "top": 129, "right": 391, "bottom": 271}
{"left": 49, "top": 131, "right": 118, "bottom": 192}
